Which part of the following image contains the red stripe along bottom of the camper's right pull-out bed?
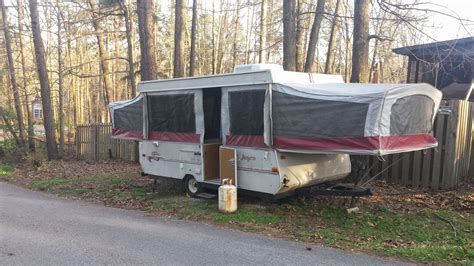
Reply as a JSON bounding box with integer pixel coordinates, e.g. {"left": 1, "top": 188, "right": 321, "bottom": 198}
{"left": 273, "top": 134, "right": 436, "bottom": 151}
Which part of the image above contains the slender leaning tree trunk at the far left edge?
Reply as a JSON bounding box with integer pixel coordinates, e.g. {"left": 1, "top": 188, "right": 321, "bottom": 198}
{"left": 0, "top": 0, "right": 26, "bottom": 145}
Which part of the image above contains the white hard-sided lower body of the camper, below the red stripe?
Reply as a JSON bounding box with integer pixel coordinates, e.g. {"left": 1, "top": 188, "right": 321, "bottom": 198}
{"left": 139, "top": 141, "right": 351, "bottom": 195}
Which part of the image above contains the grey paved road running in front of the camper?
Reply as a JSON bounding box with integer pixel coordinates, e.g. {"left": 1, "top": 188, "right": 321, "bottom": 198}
{"left": 0, "top": 182, "right": 408, "bottom": 265}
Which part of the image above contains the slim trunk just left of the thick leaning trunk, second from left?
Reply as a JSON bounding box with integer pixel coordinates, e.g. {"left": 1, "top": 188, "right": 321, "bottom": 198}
{"left": 17, "top": 0, "right": 35, "bottom": 151}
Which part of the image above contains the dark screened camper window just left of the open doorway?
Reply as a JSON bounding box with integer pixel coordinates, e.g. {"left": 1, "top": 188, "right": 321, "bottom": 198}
{"left": 147, "top": 93, "right": 196, "bottom": 133}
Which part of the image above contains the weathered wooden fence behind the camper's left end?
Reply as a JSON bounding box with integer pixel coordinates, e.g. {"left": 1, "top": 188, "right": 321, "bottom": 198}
{"left": 76, "top": 124, "right": 138, "bottom": 162}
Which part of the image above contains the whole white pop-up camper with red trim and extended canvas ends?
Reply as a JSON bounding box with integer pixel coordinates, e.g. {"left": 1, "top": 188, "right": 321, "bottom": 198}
{"left": 110, "top": 65, "right": 439, "bottom": 196}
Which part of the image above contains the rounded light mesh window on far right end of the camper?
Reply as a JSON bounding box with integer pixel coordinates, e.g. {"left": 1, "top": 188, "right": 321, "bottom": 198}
{"left": 390, "top": 95, "right": 435, "bottom": 136}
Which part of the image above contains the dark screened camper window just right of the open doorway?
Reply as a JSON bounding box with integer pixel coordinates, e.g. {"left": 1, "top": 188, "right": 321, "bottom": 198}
{"left": 229, "top": 90, "right": 265, "bottom": 136}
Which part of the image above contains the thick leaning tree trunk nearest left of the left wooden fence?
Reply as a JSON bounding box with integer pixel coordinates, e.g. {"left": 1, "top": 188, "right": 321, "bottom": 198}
{"left": 29, "top": 0, "right": 58, "bottom": 160}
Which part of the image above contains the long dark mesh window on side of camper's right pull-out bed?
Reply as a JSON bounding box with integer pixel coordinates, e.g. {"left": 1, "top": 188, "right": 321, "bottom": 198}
{"left": 272, "top": 91, "right": 369, "bottom": 138}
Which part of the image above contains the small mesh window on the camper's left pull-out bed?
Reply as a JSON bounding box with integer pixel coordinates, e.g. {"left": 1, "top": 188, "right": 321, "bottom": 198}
{"left": 114, "top": 99, "right": 143, "bottom": 132}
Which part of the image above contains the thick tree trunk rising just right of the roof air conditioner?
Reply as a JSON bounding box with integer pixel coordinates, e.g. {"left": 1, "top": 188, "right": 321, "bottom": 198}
{"left": 283, "top": 0, "right": 296, "bottom": 71}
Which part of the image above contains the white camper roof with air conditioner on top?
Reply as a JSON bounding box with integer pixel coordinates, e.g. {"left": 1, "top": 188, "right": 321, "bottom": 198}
{"left": 138, "top": 64, "right": 344, "bottom": 93}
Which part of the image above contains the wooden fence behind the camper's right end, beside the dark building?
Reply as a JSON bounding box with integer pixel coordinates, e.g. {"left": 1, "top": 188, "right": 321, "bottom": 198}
{"left": 370, "top": 100, "right": 474, "bottom": 190}
